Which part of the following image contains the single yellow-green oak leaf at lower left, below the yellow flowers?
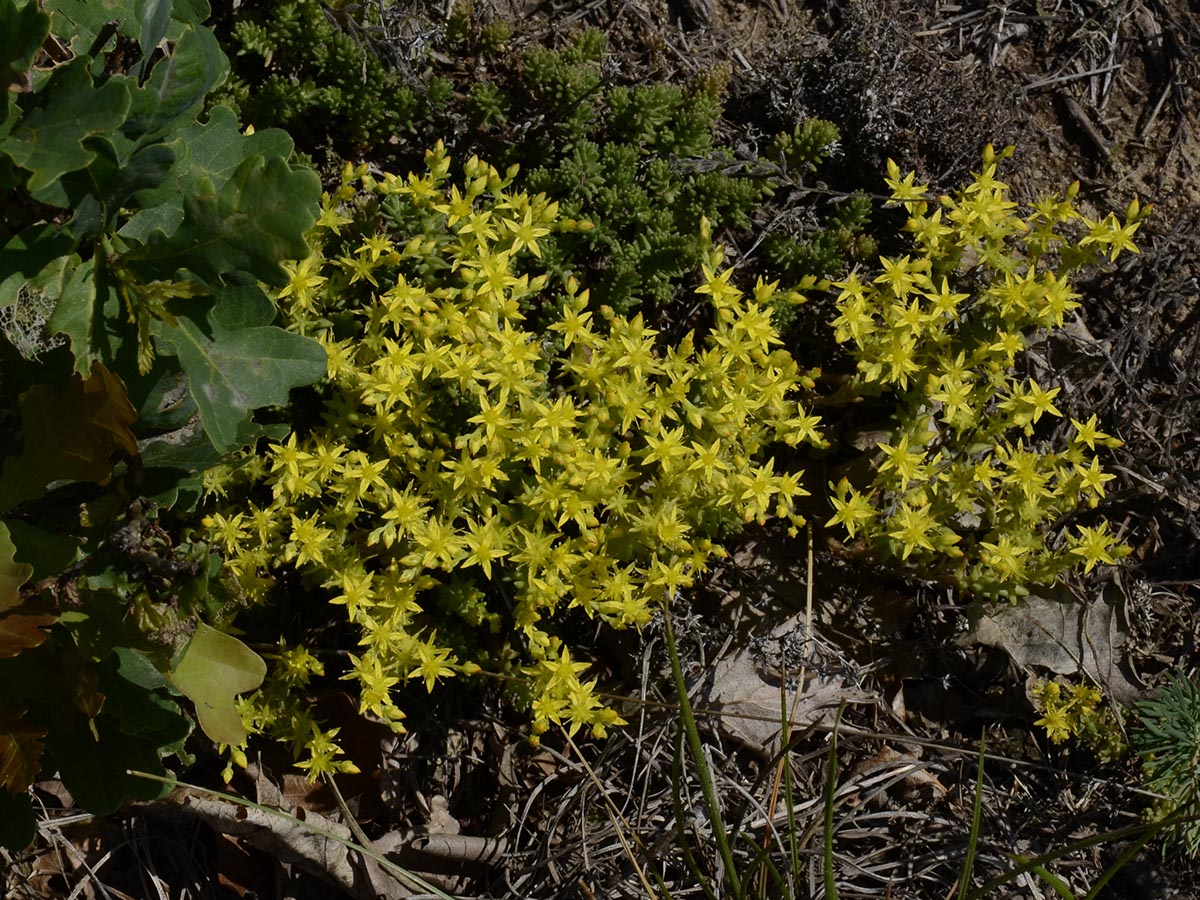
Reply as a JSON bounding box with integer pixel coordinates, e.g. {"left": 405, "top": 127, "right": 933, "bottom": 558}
{"left": 168, "top": 622, "right": 266, "bottom": 746}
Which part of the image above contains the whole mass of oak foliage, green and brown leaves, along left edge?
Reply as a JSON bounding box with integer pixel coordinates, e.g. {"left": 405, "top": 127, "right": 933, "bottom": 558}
{"left": 0, "top": 0, "right": 325, "bottom": 847}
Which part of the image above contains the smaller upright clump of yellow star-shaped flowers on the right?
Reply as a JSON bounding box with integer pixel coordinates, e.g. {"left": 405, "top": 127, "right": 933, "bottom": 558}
{"left": 829, "top": 146, "right": 1150, "bottom": 595}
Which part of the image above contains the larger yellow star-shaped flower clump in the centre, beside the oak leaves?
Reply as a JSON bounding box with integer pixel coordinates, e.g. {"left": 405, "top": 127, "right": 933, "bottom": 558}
{"left": 205, "top": 144, "right": 821, "bottom": 776}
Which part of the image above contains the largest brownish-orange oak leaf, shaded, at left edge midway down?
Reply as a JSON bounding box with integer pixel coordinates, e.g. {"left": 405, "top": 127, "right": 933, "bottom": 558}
{"left": 0, "top": 362, "right": 138, "bottom": 511}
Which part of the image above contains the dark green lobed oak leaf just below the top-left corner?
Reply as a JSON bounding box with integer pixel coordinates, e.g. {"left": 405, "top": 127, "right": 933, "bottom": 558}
{"left": 0, "top": 58, "right": 130, "bottom": 192}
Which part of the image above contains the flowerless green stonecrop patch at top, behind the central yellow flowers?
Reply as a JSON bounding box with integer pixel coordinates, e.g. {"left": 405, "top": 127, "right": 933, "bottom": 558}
{"left": 213, "top": 9, "right": 874, "bottom": 329}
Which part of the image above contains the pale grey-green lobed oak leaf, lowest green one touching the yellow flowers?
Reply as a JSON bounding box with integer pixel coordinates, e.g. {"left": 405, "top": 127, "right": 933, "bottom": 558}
{"left": 152, "top": 286, "right": 325, "bottom": 450}
